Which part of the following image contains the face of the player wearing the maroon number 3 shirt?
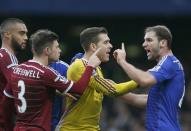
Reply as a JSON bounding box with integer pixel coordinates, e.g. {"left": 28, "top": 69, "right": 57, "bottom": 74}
{"left": 48, "top": 40, "right": 61, "bottom": 63}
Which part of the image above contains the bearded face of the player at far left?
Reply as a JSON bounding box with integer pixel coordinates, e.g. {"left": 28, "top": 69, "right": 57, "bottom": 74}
{"left": 10, "top": 23, "right": 28, "bottom": 52}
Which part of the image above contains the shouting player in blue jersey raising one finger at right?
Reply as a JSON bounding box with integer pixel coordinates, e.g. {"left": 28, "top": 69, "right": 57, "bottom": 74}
{"left": 114, "top": 25, "right": 185, "bottom": 131}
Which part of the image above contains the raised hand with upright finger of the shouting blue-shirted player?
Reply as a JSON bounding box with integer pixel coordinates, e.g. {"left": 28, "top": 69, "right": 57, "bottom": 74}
{"left": 113, "top": 43, "right": 126, "bottom": 63}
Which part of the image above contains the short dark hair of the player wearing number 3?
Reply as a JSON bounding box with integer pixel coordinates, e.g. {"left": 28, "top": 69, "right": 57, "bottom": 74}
{"left": 29, "top": 29, "right": 59, "bottom": 55}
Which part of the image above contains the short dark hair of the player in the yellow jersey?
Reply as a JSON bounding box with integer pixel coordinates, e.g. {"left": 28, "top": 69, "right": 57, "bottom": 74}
{"left": 80, "top": 27, "right": 108, "bottom": 51}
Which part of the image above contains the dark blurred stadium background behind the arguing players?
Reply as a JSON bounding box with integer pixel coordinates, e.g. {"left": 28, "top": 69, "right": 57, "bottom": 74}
{"left": 0, "top": 0, "right": 191, "bottom": 131}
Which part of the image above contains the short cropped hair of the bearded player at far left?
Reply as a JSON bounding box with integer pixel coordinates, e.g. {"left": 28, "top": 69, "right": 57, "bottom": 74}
{"left": 0, "top": 18, "right": 25, "bottom": 35}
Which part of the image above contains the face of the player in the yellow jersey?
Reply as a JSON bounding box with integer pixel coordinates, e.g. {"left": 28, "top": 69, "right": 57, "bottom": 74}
{"left": 97, "top": 33, "right": 113, "bottom": 62}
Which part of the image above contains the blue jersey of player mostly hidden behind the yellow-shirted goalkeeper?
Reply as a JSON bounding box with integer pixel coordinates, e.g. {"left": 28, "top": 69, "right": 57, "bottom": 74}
{"left": 50, "top": 60, "right": 69, "bottom": 131}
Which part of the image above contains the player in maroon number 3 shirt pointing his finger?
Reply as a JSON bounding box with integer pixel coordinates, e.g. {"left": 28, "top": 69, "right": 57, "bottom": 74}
{"left": 4, "top": 30, "right": 101, "bottom": 131}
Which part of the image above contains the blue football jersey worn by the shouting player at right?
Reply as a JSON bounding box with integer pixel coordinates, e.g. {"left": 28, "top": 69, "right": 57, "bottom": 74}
{"left": 146, "top": 55, "right": 185, "bottom": 131}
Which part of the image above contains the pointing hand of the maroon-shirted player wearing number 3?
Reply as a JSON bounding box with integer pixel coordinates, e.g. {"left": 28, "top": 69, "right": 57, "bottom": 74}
{"left": 88, "top": 47, "right": 101, "bottom": 68}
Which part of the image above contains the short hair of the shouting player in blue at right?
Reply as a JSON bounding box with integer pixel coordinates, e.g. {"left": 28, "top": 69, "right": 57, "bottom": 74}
{"left": 145, "top": 25, "right": 172, "bottom": 49}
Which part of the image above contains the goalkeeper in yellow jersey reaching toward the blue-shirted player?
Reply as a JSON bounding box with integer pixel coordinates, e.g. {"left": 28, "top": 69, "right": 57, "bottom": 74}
{"left": 56, "top": 27, "right": 137, "bottom": 131}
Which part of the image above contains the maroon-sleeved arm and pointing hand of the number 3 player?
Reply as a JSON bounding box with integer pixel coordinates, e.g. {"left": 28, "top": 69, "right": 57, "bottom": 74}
{"left": 44, "top": 49, "right": 101, "bottom": 94}
